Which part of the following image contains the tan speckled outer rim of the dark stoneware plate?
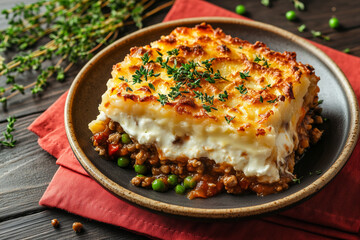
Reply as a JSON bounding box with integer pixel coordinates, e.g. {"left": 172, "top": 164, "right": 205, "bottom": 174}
{"left": 64, "top": 17, "right": 359, "bottom": 218}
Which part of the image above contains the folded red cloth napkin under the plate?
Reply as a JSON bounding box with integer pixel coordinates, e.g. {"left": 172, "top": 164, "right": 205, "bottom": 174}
{"left": 29, "top": 0, "right": 360, "bottom": 239}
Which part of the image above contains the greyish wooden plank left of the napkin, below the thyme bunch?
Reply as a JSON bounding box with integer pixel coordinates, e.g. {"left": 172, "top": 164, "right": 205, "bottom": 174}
{"left": 0, "top": 114, "right": 58, "bottom": 221}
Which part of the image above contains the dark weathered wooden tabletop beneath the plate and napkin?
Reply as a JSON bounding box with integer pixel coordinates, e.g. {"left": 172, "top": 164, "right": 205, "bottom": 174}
{"left": 0, "top": 0, "right": 360, "bottom": 239}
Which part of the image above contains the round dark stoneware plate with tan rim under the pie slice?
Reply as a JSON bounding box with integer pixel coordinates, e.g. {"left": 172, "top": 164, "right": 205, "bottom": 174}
{"left": 65, "top": 18, "right": 359, "bottom": 218}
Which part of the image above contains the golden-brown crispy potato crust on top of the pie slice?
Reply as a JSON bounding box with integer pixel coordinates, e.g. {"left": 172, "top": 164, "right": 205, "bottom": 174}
{"left": 104, "top": 23, "right": 319, "bottom": 136}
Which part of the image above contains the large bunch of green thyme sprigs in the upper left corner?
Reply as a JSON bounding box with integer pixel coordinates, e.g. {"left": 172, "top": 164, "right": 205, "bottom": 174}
{"left": 0, "top": 0, "right": 173, "bottom": 109}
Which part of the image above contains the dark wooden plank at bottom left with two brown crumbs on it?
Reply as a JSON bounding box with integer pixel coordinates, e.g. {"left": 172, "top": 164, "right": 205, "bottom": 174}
{"left": 0, "top": 209, "right": 147, "bottom": 240}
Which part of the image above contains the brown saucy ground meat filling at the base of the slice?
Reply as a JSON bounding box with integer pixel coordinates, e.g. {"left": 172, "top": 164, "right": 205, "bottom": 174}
{"left": 92, "top": 102, "right": 323, "bottom": 199}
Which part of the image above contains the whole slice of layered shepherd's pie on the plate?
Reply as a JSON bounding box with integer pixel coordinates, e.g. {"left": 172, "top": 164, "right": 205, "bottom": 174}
{"left": 89, "top": 23, "right": 322, "bottom": 199}
